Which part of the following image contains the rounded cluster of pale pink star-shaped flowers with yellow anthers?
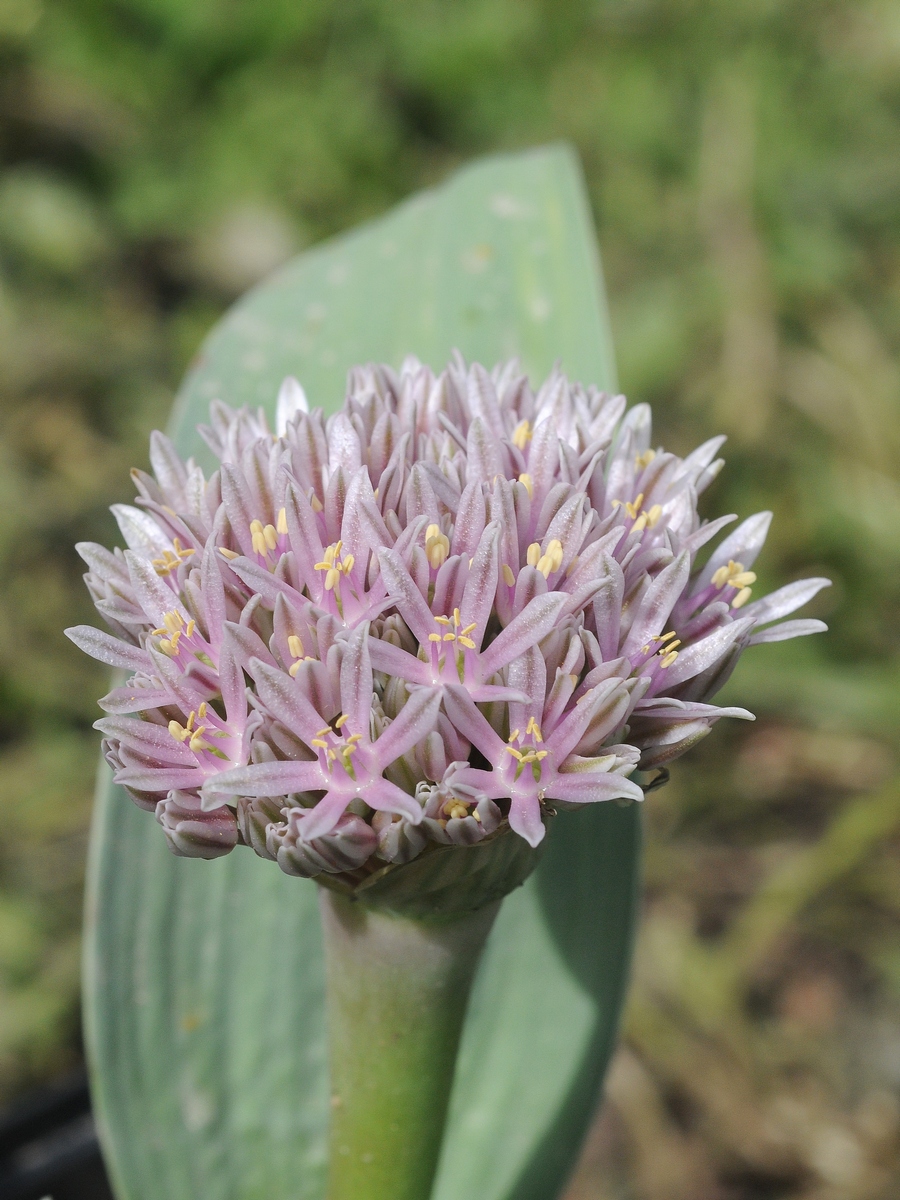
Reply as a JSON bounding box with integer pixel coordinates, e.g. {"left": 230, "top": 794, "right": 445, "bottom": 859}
{"left": 67, "top": 359, "right": 828, "bottom": 881}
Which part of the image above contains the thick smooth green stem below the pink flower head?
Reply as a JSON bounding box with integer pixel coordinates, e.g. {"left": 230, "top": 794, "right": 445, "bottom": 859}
{"left": 319, "top": 888, "right": 499, "bottom": 1200}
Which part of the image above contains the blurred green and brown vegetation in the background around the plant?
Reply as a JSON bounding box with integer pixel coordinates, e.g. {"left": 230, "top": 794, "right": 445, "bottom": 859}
{"left": 0, "top": 0, "right": 900, "bottom": 1200}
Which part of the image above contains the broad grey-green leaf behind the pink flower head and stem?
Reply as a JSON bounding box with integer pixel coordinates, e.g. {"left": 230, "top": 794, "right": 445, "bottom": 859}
{"left": 85, "top": 146, "right": 640, "bottom": 1200}
